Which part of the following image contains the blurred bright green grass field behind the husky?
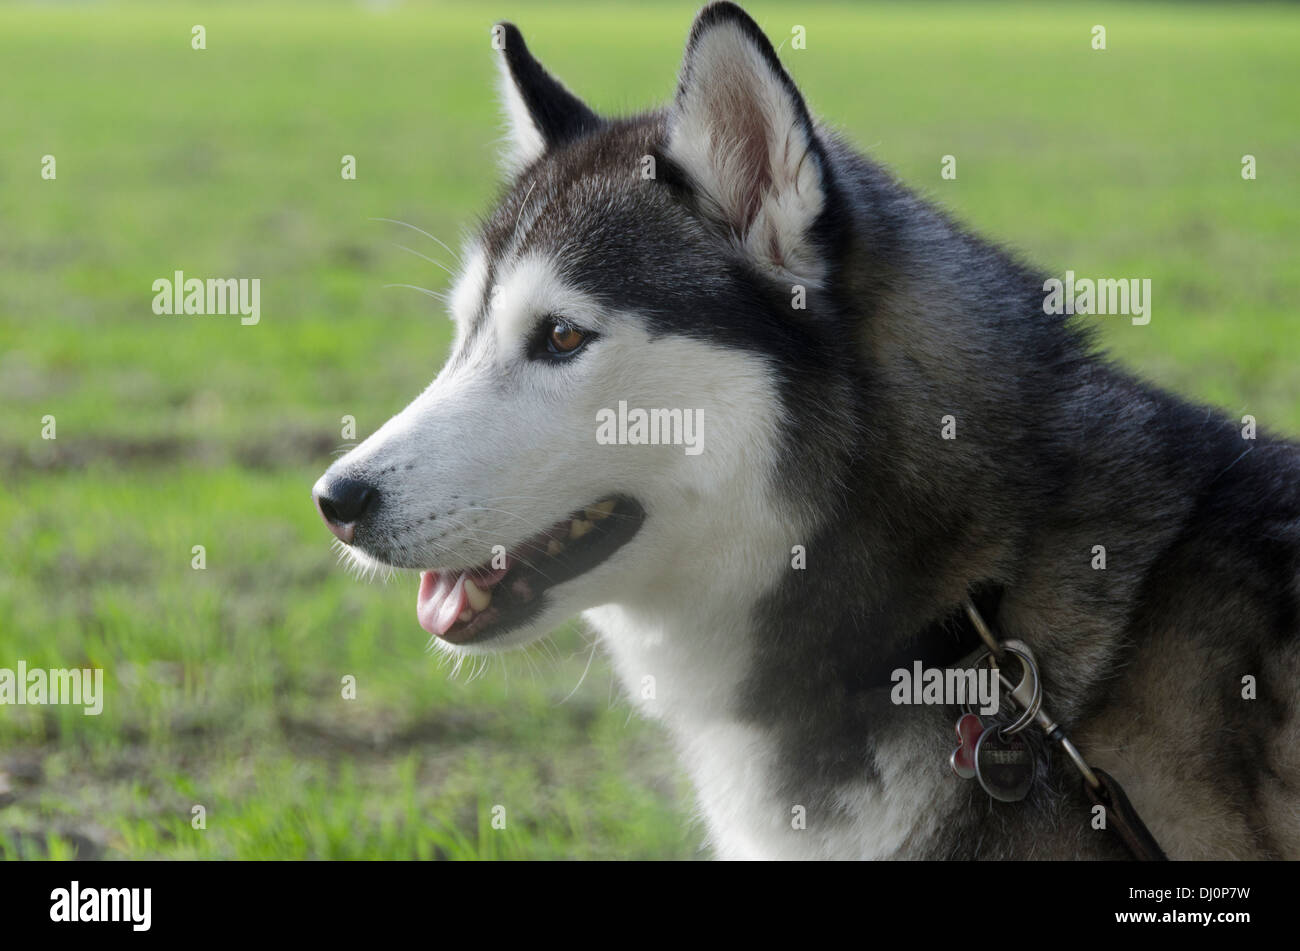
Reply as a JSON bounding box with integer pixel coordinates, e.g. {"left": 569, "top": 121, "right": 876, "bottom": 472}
{"left": 0, "top": 3, "right": 1300, "bottom": 859}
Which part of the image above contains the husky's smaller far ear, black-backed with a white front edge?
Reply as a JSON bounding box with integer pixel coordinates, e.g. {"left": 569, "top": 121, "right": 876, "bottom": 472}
{"left": 493, "top": 23, "right": 601, "bottom": 170}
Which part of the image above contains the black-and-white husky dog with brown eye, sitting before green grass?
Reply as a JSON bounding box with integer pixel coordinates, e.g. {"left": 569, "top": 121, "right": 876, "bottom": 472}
{"left": 315, "top": 3, "right": 1300, "bottom": 859}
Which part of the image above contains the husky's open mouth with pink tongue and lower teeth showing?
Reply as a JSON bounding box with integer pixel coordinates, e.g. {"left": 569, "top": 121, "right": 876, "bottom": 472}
{"left": 416, "top": 496, "right": 645, "bottom": 644}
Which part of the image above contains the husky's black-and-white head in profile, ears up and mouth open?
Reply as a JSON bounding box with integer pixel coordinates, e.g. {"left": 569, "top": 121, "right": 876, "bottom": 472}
{"left": 313, "top": 4, "right": 836, "bottom": 652}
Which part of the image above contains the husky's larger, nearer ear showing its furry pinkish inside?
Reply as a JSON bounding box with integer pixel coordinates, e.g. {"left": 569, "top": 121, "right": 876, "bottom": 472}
{"left": 664, "top": 3, "right": 828, "bottom": 275}
